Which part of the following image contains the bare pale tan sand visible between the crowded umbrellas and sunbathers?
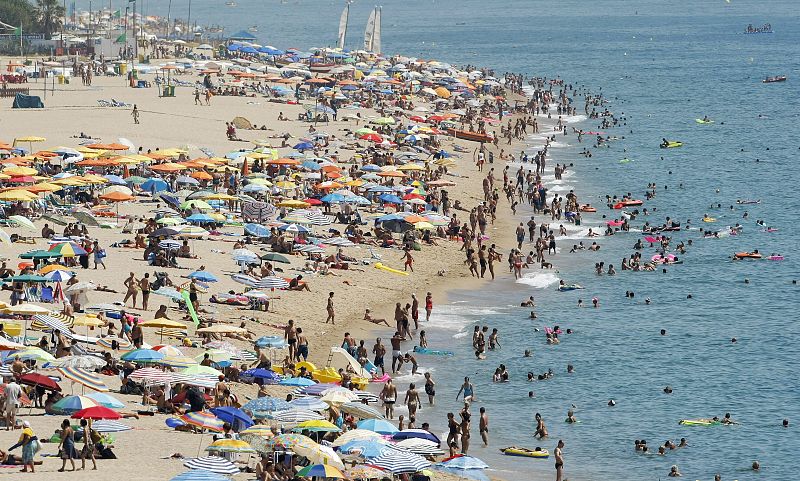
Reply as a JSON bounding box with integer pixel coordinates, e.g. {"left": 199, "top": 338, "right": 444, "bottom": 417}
{"left": 0, "top": 37, "right": 550, "bottom": 480}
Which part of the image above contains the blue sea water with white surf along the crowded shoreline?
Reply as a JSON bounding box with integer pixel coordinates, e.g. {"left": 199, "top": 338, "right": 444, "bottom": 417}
{"left": 84, "top": 0, "right": 800, "bottom": 480}
